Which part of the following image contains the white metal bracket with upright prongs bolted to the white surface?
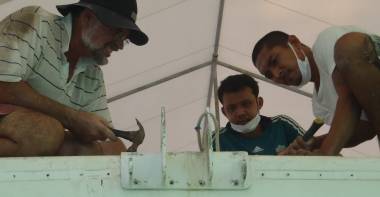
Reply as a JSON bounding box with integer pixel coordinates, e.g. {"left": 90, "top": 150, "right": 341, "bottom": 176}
{"left": 121, "top": 108, "right": 249, "bottom": 190}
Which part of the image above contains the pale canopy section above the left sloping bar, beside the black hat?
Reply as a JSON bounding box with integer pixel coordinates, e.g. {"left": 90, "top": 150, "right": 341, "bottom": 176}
{"left": 104, "top": 0, "right": 219, "bottom": 95}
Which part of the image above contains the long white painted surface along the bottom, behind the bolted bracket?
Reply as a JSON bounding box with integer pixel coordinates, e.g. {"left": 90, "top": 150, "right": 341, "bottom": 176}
{"left": 0, "top": 153, "right": 380, "bottom": 197}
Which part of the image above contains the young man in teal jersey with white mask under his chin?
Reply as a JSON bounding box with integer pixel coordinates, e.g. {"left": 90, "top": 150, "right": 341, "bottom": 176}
{"left": 214, "top": 74, "right": 304, "bottom": 155}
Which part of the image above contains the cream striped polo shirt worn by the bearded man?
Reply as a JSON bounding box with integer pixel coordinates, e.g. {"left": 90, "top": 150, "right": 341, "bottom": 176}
{"left": 0, "top": 6, "right": 111, "bottom": 122}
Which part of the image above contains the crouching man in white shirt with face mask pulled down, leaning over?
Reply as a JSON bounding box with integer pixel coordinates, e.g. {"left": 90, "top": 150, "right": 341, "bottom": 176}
{"left": 252, "top": 26, "right": 380, "bottom": 155}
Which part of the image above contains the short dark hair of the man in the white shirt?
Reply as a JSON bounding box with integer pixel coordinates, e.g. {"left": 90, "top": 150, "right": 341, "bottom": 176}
{"left": 252, "top": 31, "right": 289, "bottom": 64}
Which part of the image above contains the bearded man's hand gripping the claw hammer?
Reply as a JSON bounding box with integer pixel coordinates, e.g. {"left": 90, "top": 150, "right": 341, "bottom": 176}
{"left": 68, "top": 111, "right": 117, "bottom": 142}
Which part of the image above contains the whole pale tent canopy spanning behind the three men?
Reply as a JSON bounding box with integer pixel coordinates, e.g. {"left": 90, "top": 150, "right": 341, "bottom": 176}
{"left": 0, "top": 0, "right": 380, "bottom": 156}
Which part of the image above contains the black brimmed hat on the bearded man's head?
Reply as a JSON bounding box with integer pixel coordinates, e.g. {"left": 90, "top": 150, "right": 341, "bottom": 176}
{"left": 57, "top": 0, "right": 149, "bottom": 46}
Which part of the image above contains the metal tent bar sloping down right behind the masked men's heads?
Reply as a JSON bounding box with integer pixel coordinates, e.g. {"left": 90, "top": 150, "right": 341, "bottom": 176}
{"left": 218, "top": 61, "right": 313, "bottom": 98}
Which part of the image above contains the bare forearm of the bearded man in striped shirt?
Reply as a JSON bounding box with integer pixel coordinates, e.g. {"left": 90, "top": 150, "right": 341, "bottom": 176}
{"left": 0, "top": 82, "right": 75, "bottom": 128}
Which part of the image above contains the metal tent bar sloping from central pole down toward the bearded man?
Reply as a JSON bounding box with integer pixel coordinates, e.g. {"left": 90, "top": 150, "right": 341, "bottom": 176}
{"left": 107, "top": 61, "right": 211, "bottom": 103}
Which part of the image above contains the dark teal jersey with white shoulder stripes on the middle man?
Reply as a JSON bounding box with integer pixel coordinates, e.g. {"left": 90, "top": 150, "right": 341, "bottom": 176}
{"left": 213, "top": 115, "right": 305, "bottom": 155}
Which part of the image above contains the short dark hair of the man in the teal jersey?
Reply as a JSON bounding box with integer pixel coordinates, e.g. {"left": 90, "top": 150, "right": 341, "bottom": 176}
{"left": 218, "top": 74, "right": 259, "bottom": 104}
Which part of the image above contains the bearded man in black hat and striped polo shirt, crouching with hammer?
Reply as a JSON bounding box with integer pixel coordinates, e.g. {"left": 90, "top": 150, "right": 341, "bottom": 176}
{"left": 0, "top": 0, "right": 148, "bottom": 156}
